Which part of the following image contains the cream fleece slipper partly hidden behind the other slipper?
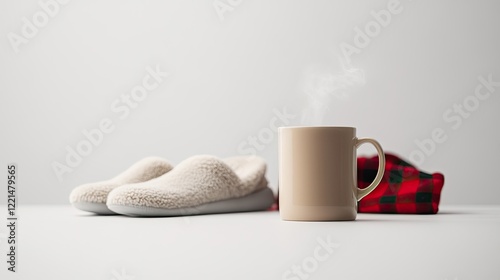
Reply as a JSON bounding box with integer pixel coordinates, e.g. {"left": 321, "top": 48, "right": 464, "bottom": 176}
{"left": 69, "top": 157, "right": 173, "bottom": 215}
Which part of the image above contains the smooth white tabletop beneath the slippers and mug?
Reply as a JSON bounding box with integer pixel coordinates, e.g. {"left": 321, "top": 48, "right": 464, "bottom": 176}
{"left": 0, "top": 206, "right": 500, "bottom": 280}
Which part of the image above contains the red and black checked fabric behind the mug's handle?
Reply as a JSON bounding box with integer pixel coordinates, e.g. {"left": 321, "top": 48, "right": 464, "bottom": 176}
{"left": 358, "top": 153, "right": 444, "bottom": 214}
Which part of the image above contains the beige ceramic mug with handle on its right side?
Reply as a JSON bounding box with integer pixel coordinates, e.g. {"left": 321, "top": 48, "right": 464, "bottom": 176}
{"left": 279, "top": 126, "right": 385, "bottom": 221}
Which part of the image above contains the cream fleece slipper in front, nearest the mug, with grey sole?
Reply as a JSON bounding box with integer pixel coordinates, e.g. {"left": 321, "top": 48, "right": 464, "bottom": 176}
{"left": 107, "top": 155, "right": 274, "bottom": 216}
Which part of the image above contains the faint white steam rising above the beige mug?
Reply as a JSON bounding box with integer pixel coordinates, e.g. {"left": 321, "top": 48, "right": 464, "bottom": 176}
{"left": 301, "top": 57, "right": 366, "bottom": 125}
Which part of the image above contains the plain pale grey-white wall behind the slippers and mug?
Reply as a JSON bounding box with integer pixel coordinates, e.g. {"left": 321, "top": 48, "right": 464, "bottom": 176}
{"left": 0, "top": 0, "right": 500, "bottom": 204}
